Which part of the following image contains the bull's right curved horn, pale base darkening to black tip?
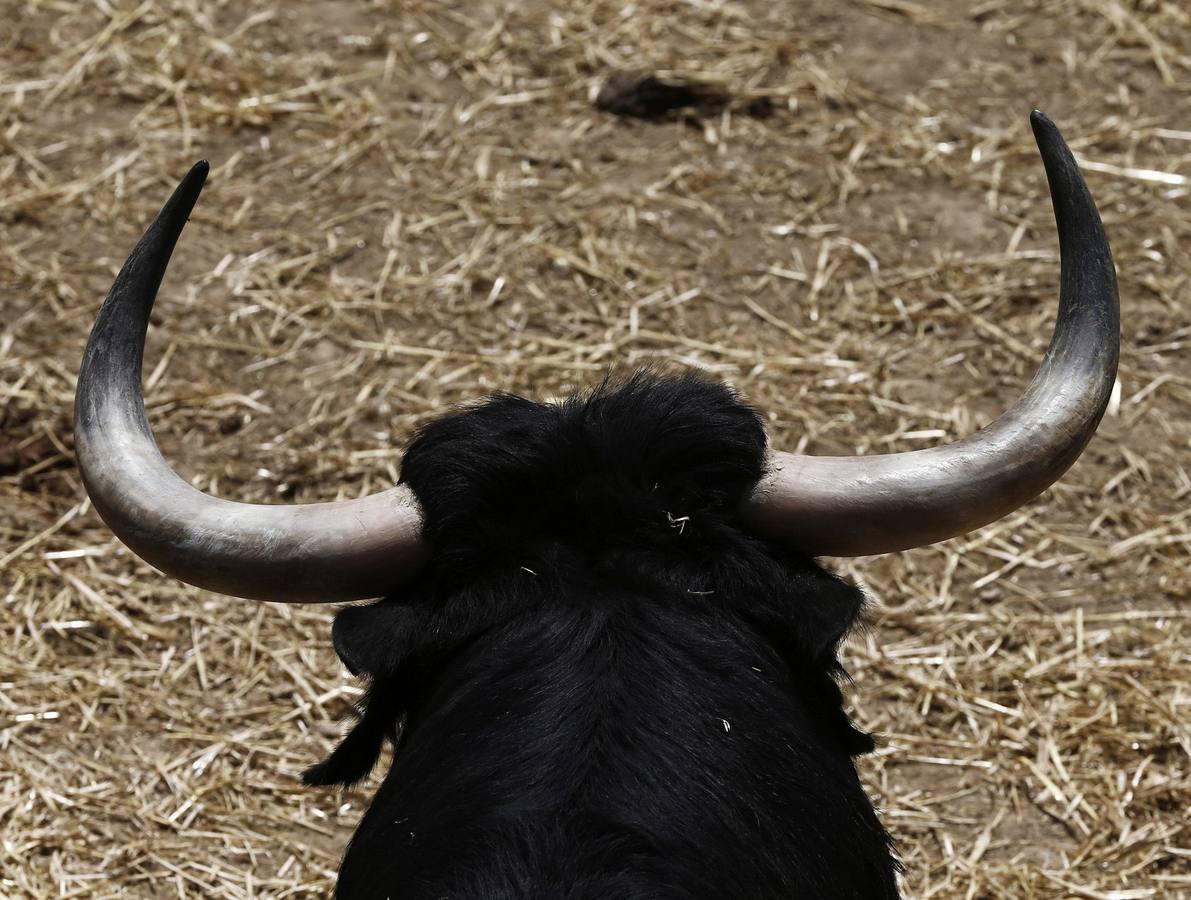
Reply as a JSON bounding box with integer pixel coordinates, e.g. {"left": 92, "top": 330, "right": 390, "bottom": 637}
{"left": 746, "top": 110, "right": 1121, "bottom": 556}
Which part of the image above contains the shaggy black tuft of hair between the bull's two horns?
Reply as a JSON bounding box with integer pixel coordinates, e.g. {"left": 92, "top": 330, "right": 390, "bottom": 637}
{"left": 403, "top": 371, "right": 766, "bottom": 565}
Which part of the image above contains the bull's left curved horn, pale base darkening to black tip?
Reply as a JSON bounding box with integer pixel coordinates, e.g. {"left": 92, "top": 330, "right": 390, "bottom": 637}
{"left": 75, "top": 162, "right": 423, "bottom": 602}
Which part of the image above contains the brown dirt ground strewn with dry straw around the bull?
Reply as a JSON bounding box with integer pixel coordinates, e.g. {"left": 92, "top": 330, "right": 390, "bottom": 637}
{"left": 0, "top": 0, "right": 1191, "bottom": 900}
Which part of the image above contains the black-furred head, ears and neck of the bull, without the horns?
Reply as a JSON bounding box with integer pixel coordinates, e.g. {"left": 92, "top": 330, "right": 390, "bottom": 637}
{"left": 307, "top": 375, "right": 897, "bottom": 900}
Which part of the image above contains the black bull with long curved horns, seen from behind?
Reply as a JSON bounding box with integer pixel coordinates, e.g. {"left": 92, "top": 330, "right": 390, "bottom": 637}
{"left": 75, "top": 112, "right": 1120, "bottom": 900}
